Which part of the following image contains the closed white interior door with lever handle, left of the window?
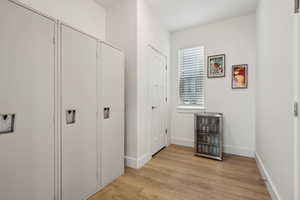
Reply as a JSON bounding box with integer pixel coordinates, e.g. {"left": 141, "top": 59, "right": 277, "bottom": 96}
{"left": 149, "top": 48, "right": 167, "bottom": 155}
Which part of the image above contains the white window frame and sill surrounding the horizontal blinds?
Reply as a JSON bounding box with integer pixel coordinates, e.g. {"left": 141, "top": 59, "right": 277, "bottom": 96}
{"left": 177, "top": 45, "right": 207, "bottom": 113}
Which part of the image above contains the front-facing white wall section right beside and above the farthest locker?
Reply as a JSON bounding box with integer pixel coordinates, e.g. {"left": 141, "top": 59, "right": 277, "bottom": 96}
{"left": 106, "top": 0, "right": 138, "bottom": 159}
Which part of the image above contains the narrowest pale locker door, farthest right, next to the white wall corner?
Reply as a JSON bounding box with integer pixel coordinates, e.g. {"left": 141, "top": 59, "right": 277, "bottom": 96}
{"left": 98, "top": 44, "right": 124, "bottom": 187}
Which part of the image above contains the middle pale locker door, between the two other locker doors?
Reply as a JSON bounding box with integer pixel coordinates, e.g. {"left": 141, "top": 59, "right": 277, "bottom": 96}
{"left": 61, "top": 25, "right": 98, "bottom": 200}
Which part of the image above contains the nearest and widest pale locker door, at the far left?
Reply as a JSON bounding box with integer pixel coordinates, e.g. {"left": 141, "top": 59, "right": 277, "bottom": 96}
{"left": 0, "top": 0, "right": 55, "bottom": 200}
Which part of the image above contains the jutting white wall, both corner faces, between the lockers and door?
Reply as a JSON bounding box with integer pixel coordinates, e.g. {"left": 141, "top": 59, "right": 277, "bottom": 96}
{"left": 107, "top": 0, "right": 170, "bottom": 167}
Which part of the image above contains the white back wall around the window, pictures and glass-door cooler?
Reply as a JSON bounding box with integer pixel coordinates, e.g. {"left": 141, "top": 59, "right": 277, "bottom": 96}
{"left": 171, "top": 14, "right": 256, "bottom": 156}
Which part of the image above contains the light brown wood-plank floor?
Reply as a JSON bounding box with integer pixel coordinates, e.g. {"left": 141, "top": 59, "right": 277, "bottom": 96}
{"left": 89, "top": 145, "right": 271, "bottom": 200}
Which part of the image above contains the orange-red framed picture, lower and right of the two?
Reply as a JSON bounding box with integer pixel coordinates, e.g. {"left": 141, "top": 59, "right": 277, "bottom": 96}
{"left": 232, "top": 64, "right": 248, "bottom": 89}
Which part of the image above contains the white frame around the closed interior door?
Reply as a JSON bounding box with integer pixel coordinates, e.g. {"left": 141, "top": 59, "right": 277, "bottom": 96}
{"left": 147, "top": 44, "right": 169, "bottom": 157}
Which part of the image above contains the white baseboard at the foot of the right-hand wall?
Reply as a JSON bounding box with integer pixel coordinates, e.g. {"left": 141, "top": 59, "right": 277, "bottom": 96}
{"left": 255, "top": 153, "right": 281, "bottom": 200}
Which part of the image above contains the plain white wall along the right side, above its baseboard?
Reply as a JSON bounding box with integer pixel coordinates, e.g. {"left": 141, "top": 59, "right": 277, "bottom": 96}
{"left": 256, "top": 0, "right": 298, "bottom": 200}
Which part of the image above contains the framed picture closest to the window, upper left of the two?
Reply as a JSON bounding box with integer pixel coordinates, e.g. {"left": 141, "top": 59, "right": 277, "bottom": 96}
{"left": 207, "top": 54, "right": 226, "bottom": 78}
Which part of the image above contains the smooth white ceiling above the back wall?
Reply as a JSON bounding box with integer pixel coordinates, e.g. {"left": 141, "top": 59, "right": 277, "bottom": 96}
{"left": 146, "top": 0, "right": 257, "bottom": 32}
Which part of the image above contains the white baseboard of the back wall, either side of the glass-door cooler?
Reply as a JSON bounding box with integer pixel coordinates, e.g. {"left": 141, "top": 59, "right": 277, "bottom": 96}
{"left": 171, "top": 138, "right": 254, "bottom": 158}
